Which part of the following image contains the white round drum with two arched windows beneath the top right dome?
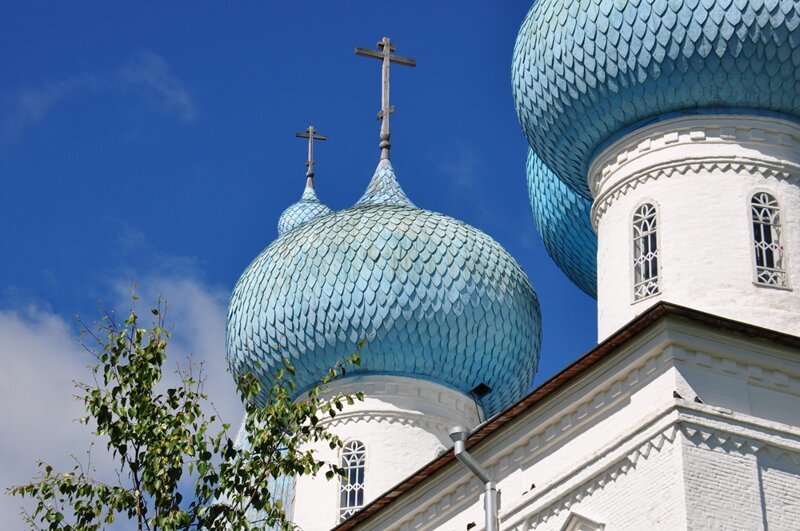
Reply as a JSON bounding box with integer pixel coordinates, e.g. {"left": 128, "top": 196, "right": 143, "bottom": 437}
{"left": 588, "top": 115, "right": 800, "bottom": 340}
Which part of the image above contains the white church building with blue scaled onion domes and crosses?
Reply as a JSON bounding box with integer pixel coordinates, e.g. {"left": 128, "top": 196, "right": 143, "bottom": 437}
{"left": 223, "top": 0, "right": 800, "bottom": 531}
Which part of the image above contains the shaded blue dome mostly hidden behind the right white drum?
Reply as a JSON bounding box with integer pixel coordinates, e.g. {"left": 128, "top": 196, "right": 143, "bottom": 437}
{"left": 528, "top": 149, "right": 597, "bottom": 299}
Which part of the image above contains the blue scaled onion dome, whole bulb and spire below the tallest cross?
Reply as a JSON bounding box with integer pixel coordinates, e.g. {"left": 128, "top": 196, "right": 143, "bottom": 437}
{"left": 227, "top": 160, "right": 541, "bottom": 415}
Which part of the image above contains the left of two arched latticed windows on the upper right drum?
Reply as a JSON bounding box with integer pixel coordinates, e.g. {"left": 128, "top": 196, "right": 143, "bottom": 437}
{"left": 633, "top": 203, "right": 659, "bottom": 301}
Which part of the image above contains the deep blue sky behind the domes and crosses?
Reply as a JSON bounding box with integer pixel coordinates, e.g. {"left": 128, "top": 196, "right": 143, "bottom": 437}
{"left": 0, "top": 0, "right": 596, "bottom": 513}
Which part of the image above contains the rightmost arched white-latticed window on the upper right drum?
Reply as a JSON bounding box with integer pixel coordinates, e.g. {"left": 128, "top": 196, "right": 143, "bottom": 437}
{"left": 750, "top": 192, "right": 787, "bottom": 287}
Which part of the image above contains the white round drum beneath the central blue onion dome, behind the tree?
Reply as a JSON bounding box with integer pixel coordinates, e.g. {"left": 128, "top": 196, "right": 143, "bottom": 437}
{"left": 294, "top": 375, "right": 482, "bottom": 531}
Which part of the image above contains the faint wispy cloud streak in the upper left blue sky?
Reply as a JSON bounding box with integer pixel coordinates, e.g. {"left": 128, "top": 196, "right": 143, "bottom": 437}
{"left": 0, "top": 51, "right": 197, "bottom": 142}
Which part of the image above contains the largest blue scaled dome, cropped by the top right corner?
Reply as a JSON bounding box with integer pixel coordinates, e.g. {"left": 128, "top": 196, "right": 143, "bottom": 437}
{"left": 512, "top": 0, "right": 800, "bottom": 198}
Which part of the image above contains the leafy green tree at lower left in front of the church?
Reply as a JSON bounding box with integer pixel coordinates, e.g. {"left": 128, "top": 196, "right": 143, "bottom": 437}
{"left": 9, "top": 297, "right": 363, "bottom": 531}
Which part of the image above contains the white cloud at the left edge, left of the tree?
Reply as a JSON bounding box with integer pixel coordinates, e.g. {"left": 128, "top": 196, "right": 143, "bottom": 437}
{"left": 0, "top": 308, "right": 99, "bottom": 529}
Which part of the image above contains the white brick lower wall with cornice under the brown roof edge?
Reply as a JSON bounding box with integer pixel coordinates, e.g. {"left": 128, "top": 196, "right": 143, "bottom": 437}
{"left": 352, "top": 316, "right": 800, "bottom": 531}
